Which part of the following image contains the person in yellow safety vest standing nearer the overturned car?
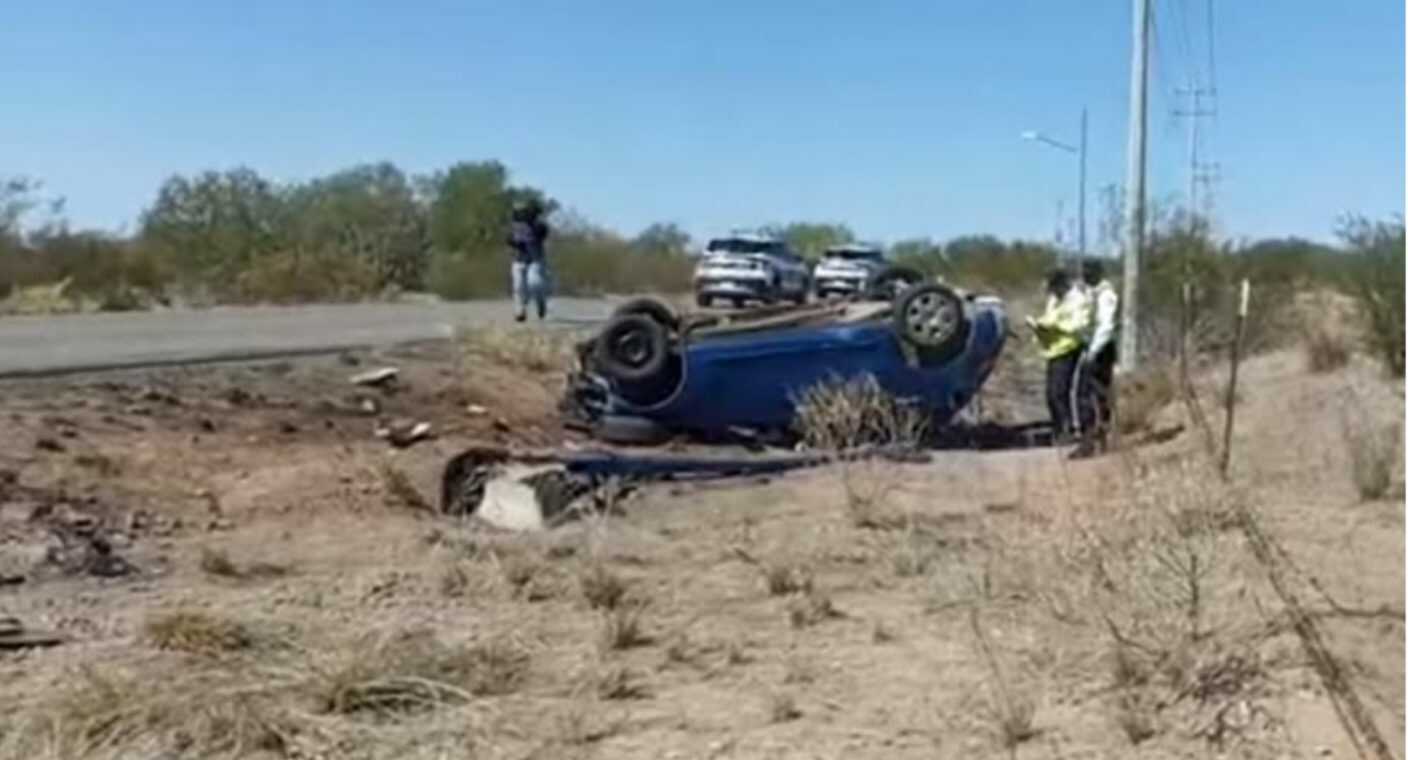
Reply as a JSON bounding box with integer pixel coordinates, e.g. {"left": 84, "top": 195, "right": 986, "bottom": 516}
{"left": 1026, "top": 270, "right": 1090, "bottom": 442}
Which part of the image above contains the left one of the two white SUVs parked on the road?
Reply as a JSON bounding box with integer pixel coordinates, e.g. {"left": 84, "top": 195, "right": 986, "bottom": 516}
{"left": 694, "top": 234, "right": 811, "bottom": 307}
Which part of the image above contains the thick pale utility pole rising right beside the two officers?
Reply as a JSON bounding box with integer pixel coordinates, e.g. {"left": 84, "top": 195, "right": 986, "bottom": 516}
{"left": 1119, "top": 0, "right": 1149, "bottom": 373}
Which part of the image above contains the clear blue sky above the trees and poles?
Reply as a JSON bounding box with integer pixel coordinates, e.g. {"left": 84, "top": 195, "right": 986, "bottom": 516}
{"left": 0, "top": 0, "right": 1404, "bottom": 241}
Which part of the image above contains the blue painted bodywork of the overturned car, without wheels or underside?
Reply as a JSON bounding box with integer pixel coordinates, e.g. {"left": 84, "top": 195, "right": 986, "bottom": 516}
{"left": 601, "top": 298, "right": 1007, "bottom": 433}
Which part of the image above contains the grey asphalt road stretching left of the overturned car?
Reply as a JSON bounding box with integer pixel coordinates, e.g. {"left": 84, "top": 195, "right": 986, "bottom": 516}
{"left": 0, "top": 298, "right": 611, "bottom": 377}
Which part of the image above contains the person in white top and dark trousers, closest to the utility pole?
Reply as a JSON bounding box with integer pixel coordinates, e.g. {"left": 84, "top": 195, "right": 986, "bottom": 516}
{"left": 1071, "top": 259, "right": 1119, "bottom": 459}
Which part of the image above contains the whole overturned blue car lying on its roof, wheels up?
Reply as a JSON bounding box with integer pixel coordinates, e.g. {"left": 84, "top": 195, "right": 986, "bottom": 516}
{"left": 562, "top": 272, "right": 1008, "bottom": 443}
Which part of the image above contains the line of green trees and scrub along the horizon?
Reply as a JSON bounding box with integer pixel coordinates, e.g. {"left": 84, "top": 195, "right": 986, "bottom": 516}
{"left": 0, "top": 160, "right": 1404, "bottom": 367}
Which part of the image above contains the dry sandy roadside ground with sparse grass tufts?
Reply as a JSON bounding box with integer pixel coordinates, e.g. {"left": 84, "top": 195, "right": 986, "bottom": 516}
{"left": 0, "top": 327, "right": 1404, "bottom": 759}
